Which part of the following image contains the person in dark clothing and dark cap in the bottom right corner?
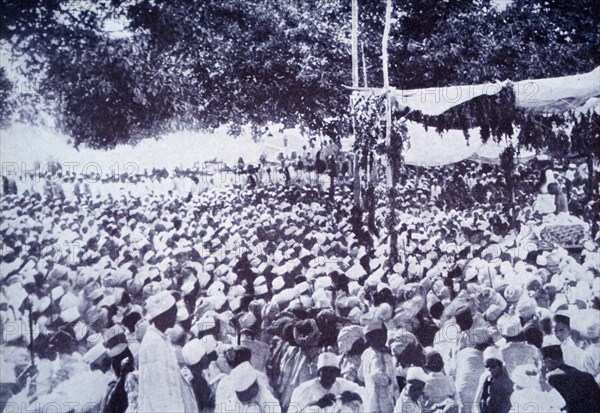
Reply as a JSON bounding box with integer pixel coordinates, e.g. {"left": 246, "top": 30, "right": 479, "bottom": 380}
{"left": 542, "top": 344, "right": 600, "bottom": 413}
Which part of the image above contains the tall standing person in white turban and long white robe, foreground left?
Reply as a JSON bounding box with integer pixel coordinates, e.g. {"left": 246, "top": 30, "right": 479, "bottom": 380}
{"left": 138, "top": 291, "right": 198, "bottom": 412}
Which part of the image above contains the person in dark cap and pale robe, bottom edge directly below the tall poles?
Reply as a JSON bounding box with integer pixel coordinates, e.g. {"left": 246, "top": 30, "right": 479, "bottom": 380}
{"left": 359, "top": 320, "right": 399, "bottom": 413}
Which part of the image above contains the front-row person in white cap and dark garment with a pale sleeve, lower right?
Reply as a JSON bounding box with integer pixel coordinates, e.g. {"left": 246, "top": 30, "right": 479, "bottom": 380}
{"left": 476, "top": 347, "right": 513, "bottom": 413}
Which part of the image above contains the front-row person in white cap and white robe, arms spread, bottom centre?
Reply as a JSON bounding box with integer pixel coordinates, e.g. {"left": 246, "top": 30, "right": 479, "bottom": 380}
{"left": 288, "top": 352, "right": 366, "bottom": 413}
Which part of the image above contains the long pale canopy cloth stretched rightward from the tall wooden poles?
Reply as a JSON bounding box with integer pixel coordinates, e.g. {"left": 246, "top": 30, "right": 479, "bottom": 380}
{"left": 354, "top": 67, "right": 600, "bottom": 116}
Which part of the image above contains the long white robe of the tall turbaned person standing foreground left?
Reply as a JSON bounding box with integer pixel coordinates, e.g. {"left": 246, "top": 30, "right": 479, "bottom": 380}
{"left": 138, "top": 326, "right": 198, "bottom": 412}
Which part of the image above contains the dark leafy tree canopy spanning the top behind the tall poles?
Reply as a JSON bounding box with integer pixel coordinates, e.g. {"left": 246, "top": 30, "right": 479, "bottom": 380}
{"left": 0, "top": 0, "right": 600, "bottom": 148}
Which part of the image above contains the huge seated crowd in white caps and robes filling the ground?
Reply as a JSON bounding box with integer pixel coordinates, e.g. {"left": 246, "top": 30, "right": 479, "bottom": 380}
{"left": 0, "top": 151, "right": 600, "bottom": 413}
